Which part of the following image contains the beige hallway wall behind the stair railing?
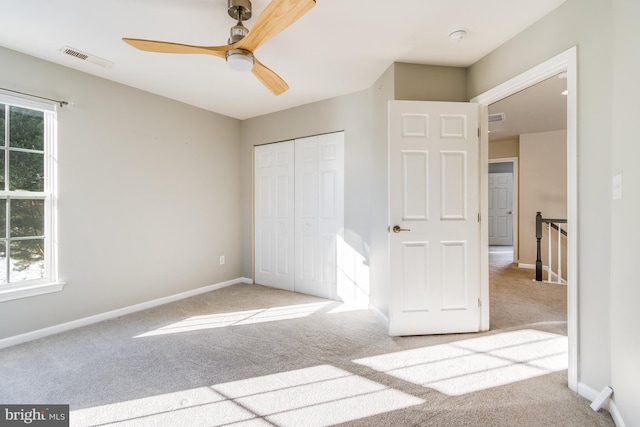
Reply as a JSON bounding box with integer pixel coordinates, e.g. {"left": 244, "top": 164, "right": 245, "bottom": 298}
{"left": 518, "top": 131, "right": 567, "bottom": 278}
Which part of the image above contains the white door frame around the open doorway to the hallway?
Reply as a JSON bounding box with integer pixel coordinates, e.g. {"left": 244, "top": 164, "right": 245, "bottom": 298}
{"left": 471, "top": 46, "right": 579, "bottom": 392}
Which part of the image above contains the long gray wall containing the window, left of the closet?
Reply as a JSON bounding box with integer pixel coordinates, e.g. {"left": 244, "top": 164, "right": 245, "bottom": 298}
{"left": 0, "top": 48, "right": 242, "bottom": 339}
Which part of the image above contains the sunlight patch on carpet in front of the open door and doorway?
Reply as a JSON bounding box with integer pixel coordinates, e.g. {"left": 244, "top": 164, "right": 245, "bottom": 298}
{"left": 353, "top": 329, "right": 568, "bottom": 396}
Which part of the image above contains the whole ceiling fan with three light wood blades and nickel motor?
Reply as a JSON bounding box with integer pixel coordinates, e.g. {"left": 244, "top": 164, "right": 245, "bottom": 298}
{"left": 122, "top": 0, "right": 316, "bottom": 95}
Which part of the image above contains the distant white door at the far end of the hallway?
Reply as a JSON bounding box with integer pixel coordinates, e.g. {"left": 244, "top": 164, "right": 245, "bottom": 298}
{"left": 489, "top": 172, "right": 513, "bottom": 246}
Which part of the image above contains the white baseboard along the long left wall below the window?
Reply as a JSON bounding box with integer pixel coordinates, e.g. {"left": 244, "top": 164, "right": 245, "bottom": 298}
{"left": 0, "top": 277, "right": 253, "bottom": 349}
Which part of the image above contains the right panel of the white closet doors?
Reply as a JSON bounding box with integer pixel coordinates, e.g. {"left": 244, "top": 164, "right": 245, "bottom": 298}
{"left": 295, "top": 132, "right": 344, "bottom": 299}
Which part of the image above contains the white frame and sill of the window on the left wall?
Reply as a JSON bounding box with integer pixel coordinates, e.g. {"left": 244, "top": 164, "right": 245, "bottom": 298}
{"left": 0, "top": 93, "right": 65, "bottom": 302}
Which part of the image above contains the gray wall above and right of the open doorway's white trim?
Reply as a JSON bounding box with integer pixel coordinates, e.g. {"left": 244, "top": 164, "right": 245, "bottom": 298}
{"left": 468, "top": 0, "right": 612, "bottom": 410}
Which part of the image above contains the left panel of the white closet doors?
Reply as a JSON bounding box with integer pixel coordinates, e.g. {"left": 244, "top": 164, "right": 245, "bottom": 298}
{"left": 254, "top": 141, "right": 295, "bottom": 291}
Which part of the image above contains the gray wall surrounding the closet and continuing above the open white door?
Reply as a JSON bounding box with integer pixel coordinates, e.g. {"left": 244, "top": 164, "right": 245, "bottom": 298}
{"left": 241, "top": 63, "right": 466, "bottom": 315}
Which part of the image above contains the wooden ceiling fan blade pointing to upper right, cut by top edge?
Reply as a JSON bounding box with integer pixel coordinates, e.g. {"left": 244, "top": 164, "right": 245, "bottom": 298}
{"left": 236, "top": 0, "right": 316, "bottom": 52}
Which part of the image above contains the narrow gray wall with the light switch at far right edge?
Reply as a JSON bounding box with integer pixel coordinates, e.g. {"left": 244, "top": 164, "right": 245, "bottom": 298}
{"left": 603, "top": 0, "right": 640, "bottom": 426}
